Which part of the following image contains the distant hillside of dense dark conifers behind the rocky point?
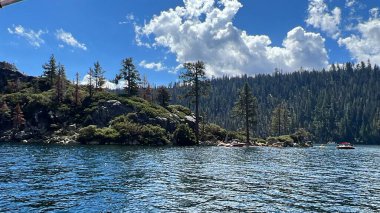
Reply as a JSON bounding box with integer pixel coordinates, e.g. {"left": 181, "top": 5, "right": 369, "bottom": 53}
{"left": 170, "top": 62, "right": 380, "bottom": 144}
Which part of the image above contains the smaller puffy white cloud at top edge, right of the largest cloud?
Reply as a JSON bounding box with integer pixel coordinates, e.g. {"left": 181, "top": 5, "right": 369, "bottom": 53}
{"left": 306, "top": 0, "right": 342, "bottom": 39}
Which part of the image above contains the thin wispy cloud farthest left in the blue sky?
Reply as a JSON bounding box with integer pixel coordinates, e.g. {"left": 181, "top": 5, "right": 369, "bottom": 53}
{"left": 8, "top": 25, "right": 48, "bottom": 48}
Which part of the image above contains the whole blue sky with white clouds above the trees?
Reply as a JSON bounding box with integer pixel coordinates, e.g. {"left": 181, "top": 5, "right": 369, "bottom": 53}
{"left": 0, "top": 0, "right": 380, "bottom": 85}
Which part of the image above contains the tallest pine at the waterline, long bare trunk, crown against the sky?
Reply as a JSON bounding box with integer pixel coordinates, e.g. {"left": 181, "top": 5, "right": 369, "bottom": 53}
{"left": 180, "top": 61, "right": 209, "bottom": 143}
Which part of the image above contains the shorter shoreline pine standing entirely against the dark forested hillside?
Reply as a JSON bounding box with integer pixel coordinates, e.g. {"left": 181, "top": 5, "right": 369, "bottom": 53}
{"left": 233, "top": 82, "right": 257, "bottom": 145}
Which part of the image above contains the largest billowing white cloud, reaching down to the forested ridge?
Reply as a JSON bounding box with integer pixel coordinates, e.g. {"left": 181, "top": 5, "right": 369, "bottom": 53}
{"left": 135, "top": 0, "right": 328, "bottom": 76}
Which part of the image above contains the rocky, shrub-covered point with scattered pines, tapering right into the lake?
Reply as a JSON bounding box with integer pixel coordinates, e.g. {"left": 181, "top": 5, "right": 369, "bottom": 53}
{"left": 0, "top": 59, "right": 312, "bottom": 147}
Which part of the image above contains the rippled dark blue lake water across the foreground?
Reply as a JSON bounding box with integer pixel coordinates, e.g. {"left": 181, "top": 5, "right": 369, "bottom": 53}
{"left": 0, "top": 144, "right": 380, "bottom": 212}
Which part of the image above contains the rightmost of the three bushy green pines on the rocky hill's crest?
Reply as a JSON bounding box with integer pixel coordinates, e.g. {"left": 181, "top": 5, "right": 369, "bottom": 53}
{"left": 115, "top": 58, "right": 141, "bottom": 97}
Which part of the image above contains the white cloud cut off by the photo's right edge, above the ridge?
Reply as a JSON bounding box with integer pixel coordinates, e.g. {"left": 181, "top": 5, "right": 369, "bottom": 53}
{"left": 338, "top": 16, "right": 380, "bottom": 64}
